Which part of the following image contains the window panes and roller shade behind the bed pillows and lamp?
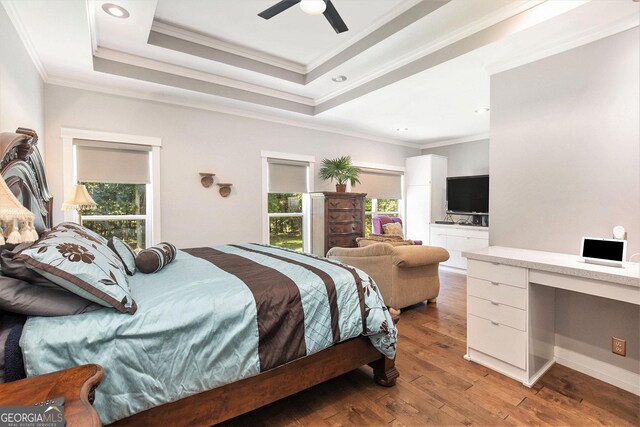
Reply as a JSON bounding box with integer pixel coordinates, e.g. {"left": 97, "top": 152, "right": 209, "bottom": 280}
{"left": 75, "top": 140, "right": 152, "bottom": 249}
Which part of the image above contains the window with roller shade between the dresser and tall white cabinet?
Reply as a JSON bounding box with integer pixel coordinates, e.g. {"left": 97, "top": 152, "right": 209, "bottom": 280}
{"left": 354, "top": 168, "right": 402, "bottom": 236}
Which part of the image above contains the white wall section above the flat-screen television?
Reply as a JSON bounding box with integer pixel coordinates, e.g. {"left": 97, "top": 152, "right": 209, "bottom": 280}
{"left": 422, "top": 139, "right": 489, "bottom": 176}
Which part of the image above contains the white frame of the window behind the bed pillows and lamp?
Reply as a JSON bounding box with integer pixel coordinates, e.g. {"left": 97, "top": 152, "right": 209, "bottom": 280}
{"left": 60, "top": 128, "right": 162, "bottom": 247}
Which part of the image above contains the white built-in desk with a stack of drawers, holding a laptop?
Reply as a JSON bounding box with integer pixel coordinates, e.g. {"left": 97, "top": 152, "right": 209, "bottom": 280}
{"left": 462, "top": 246, "right": 640, "bottom": 394}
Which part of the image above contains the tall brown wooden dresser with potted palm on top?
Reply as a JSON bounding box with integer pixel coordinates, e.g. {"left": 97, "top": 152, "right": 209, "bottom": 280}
{"left": 311, "top": 191, "right": 366, "bottom": 256}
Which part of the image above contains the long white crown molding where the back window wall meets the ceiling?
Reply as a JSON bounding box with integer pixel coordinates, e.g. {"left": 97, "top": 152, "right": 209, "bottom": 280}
{"left": 47, "top": 77, "right": 421, "bottom": 149}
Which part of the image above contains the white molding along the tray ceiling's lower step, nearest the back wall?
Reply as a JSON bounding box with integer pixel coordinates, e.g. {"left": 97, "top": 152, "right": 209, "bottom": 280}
{"left": 94, "top": 47, "right": 315, "bottom": 107}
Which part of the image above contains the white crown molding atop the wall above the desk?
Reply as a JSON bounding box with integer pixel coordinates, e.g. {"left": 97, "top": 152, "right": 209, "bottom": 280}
{"left": 485, "top": 14, "right": 640, "bottom": 76}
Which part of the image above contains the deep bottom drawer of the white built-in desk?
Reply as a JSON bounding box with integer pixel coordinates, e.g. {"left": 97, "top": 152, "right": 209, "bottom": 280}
{"left": 467, "top": 314, "right": 527, "bottom": 369}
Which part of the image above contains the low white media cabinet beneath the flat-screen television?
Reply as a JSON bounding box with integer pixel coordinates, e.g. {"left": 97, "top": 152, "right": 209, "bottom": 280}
{"left": 429, "top": 224, "right": 489, "bottom": 270}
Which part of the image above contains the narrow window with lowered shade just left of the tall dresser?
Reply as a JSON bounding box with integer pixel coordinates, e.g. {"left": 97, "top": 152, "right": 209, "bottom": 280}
{"left": 267, "top": 158, "right": 309, "bottom": 251}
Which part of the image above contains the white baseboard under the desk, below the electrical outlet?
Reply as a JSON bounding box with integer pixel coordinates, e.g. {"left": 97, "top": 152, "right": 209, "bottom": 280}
{"left": 555, "top": 347, "right": 640, "bottom": 396}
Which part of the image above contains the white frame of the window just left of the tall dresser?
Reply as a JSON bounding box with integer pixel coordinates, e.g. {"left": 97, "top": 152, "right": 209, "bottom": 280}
{"left": 260, "top": 151, "right": 316, "bottom": 253}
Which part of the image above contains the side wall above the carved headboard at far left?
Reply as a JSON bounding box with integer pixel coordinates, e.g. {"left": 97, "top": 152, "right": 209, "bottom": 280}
{"left": 0, "top": 4, "right": 44, "bottom": 153}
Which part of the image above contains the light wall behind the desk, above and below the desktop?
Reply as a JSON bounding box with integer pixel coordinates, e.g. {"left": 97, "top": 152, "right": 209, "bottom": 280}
{"left": 490, "top": 28, "right": 640, "bottom": 381}
